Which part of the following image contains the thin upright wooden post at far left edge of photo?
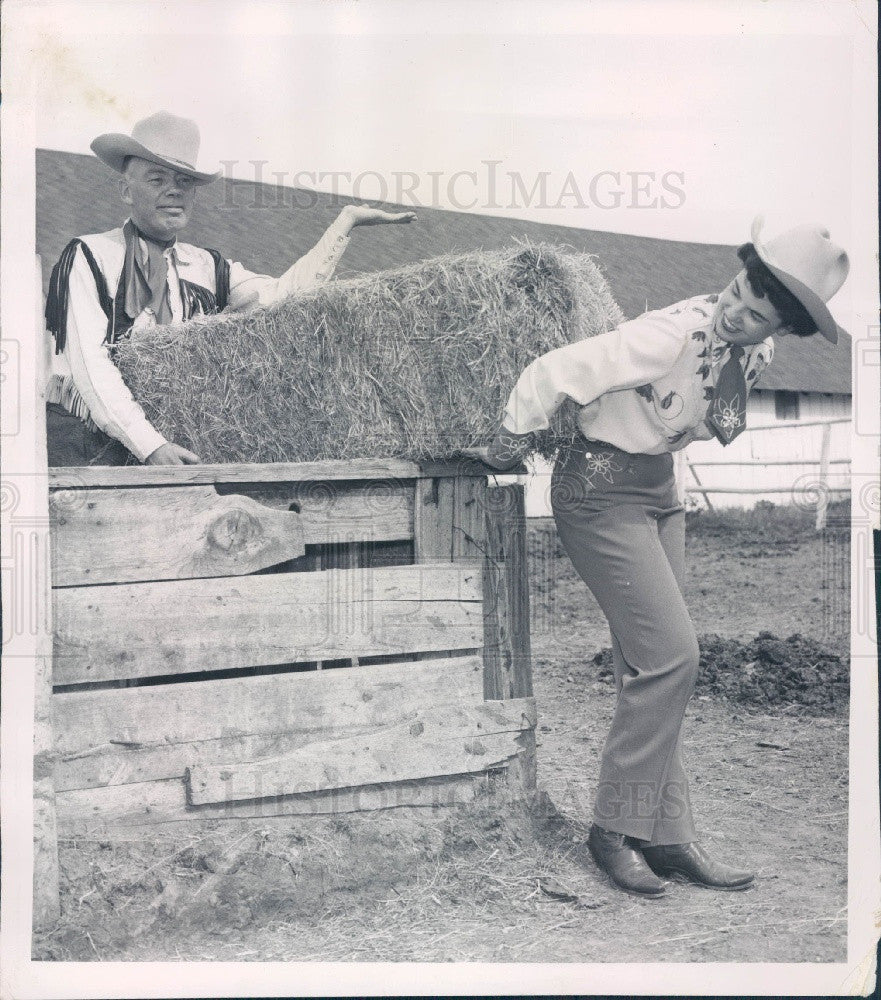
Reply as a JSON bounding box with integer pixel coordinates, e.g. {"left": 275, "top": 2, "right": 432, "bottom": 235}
{"left": 32, "top": 256, "right": 60, "bottom": 930}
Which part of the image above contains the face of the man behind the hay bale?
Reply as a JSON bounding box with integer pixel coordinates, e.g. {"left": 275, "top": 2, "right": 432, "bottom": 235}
{"left": 120, "top": 156, "right": 196, "bottom": 240}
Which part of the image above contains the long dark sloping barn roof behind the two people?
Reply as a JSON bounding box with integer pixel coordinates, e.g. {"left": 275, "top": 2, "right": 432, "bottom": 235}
{"left": 37, "top": 150, "right": 851, "bottom": 393}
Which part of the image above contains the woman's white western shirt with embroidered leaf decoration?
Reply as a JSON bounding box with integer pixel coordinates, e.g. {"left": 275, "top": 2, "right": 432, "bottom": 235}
{"left": 502, "top": 295, "right": 774, "bottom": 455}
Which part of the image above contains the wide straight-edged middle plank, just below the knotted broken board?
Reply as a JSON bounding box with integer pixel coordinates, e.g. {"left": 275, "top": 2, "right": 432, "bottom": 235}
{"left": 53, "top": 563, "right": 483, "bottom": 685}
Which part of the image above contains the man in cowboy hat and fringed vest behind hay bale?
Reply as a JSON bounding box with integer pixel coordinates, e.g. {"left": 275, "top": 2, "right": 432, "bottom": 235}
{"left": 46, "top": 111, "right": 416, "bottom": 465}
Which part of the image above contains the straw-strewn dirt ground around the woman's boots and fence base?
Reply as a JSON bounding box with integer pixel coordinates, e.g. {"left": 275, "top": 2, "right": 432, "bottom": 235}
{"left": 34, "top": 508, "right": 849, "bottom": 962}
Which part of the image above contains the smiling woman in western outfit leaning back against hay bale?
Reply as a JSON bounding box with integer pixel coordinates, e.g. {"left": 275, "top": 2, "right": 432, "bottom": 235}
{"left": 476, "top": 219, "right": 848, "bottom": 897}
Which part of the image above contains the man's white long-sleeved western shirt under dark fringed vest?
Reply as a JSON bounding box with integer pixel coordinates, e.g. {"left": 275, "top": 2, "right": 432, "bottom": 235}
{"left": 46, "top": 221, "right": 349, "bottom": 462}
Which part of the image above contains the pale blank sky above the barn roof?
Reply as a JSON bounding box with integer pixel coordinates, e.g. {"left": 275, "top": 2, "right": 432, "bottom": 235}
{"left": 13, "top": 0, "right": 874, "bottom": 320}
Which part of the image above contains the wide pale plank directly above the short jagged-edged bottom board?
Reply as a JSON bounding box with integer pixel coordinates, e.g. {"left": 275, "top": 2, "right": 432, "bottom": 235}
{"left": 53, "top": 656, "right": 483, "bottom": 790}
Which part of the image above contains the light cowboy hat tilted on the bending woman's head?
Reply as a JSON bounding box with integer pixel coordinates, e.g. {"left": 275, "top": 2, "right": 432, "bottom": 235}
{"left": 752, "top": 215, "right": 850, "bottom": 344}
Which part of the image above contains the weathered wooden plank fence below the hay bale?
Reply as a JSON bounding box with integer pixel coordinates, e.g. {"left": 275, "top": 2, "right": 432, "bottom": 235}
{"left": 36, "top": 460, "right": 535, "bottom": 918}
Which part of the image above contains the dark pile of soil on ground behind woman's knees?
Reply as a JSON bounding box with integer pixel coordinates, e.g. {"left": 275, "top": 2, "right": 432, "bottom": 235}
{"left": 593, "top": 632, "right": 849, "bottom": 715}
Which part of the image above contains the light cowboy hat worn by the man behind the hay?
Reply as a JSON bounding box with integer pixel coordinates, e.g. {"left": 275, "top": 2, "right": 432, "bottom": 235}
{"left": 91, "top": 111, "right": 220, "bottom": 184}
